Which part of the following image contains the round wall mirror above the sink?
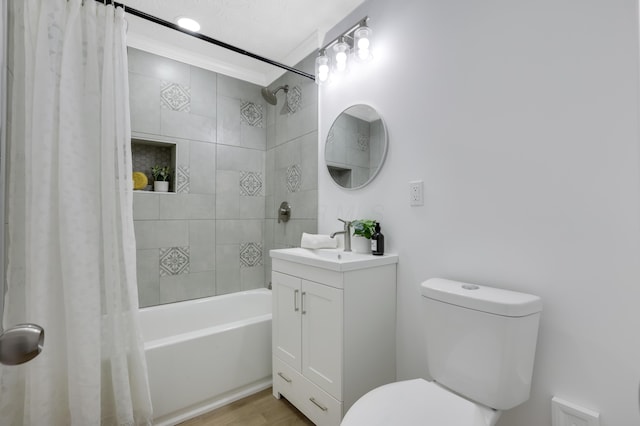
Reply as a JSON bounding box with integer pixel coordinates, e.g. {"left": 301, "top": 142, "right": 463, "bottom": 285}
{"left": 324, "top": 105, "right": 387, "bottom": 189}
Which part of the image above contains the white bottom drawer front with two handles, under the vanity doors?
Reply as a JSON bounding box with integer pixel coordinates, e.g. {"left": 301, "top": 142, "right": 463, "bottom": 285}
{"left": 273, "top": 357, "right": 342, "bottom": 426}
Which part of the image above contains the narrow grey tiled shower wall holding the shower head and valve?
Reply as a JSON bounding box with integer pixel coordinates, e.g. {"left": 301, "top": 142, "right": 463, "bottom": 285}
{"left": 265, "top": 55, "right": 318, "bottom": 280}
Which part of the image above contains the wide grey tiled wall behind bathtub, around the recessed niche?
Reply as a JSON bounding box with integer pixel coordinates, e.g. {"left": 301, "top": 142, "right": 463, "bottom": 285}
{"left": 129, "top": 48, "right": 266, "bottom": 306}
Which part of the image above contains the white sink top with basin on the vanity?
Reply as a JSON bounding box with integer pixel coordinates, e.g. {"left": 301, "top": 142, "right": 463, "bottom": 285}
{"left": 269, "top": 248, "right": 398, "bottom": 272}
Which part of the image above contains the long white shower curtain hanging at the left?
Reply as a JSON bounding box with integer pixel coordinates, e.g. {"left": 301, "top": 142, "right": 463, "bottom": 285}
{"left": 0, "top": 0, "right": 152, "bottom": 426}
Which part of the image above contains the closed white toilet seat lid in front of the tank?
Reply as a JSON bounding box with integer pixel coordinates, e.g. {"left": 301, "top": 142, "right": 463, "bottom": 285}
{"left": 341, "top": 379, "right": 500, "bottom": 426}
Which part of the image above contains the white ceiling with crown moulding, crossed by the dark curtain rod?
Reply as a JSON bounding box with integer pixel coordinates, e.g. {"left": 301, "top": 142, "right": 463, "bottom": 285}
{"left": 121, "top": 0, "right": 364, "bottom": 86}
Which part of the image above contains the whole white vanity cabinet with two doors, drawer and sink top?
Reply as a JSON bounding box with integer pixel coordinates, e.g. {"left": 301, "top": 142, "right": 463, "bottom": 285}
{"left": 271, "top": 249, "right": 397, "bottom": 426}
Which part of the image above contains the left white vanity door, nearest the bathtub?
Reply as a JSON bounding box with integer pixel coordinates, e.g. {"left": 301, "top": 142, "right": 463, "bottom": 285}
{"left": 271, "top": 272, "right": 302, "bottom": 371}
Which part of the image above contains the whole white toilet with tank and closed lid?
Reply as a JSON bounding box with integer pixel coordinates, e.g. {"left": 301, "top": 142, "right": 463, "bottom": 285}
{"left": 341, "top": 278, "right": 542, "bottom": 426}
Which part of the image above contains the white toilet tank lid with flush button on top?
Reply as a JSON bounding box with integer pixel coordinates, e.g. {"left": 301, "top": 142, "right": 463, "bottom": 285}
{"left": 421, "top": 278, "right": 542, "bottom": 317}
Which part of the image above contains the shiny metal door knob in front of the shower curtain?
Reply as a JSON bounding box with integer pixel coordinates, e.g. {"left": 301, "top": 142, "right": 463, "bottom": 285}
{"left": 0, "top": 324, "right": 44, "bottom": 365}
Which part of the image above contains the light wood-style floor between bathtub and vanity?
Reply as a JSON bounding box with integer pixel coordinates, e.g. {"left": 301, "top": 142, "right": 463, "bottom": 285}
{"left": 180, "top": 388, "right": 313, "bottom": 426}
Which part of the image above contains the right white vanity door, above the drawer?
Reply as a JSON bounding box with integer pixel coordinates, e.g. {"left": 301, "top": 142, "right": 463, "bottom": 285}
{"left": 300, "top": 280, "right": 343, "bottom": 401}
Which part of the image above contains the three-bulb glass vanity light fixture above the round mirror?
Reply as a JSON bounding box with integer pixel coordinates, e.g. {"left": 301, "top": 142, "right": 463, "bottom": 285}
{"left": 316, "top": 17, "right": 373, "bottom": 84}
